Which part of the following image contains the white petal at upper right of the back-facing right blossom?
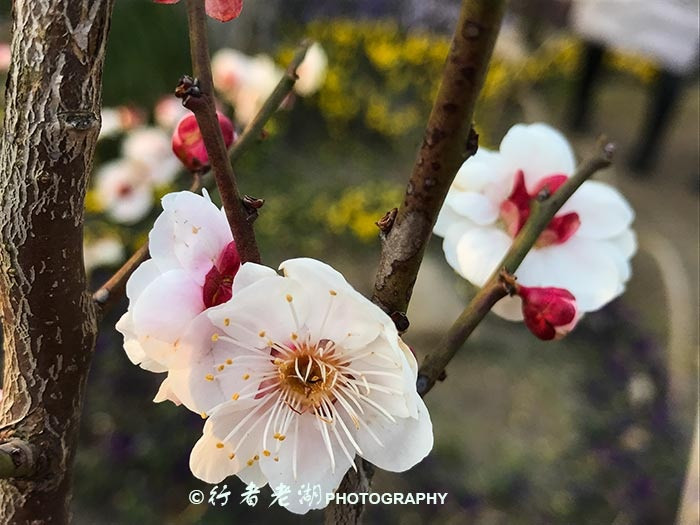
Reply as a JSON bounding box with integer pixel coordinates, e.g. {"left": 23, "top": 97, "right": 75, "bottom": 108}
{"left": 558, "top": 180, "right": 634, "bottom": 239}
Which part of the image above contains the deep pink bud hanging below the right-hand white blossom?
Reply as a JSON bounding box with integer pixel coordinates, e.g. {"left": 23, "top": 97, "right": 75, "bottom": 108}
{"left": 517, "top": 285, "right": 580, "bottom": 341}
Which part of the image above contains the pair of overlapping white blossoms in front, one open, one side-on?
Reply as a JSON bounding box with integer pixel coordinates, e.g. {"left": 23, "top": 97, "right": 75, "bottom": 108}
{"left": 117, "top": 192, "right": 433, "bottom": 513}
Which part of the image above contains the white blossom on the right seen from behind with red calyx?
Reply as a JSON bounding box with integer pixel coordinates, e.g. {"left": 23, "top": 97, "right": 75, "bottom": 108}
{"left": 434, "top": 124, "right": 637, "bottom": 320}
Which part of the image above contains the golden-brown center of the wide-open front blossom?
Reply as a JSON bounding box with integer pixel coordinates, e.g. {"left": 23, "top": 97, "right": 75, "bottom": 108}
{"left": 275, "top": 341, "right": 340, "bottom": 413}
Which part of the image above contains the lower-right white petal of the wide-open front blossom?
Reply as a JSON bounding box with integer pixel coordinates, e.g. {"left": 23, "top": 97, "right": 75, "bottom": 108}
{"left": 357, "top": 394, "right": 433, "bottom": 472}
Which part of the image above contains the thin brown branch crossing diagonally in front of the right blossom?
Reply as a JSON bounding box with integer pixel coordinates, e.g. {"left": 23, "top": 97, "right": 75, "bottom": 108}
{"left": 417, "top": 144, "right": 614, "bottom": 396}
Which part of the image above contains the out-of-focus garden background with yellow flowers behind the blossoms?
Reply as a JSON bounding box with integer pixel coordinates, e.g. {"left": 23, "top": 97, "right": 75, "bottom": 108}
{"left": 0, "top": 0, "right": 700, "bottom": 525}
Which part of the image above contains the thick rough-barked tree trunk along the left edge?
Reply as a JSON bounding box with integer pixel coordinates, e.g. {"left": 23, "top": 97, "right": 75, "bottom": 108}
{"left": 0, "top": 0, "right": 114, "bottom": 524}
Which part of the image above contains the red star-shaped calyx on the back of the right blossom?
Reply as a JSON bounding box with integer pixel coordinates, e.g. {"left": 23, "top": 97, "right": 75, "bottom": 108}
{"left": 501, "top": 170, "right": 581, "bottom": 248}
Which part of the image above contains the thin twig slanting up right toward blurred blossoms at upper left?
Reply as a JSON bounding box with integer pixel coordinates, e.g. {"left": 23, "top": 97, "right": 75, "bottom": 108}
{"left": 229, "top": 40, "right": 312, "bottom": 164}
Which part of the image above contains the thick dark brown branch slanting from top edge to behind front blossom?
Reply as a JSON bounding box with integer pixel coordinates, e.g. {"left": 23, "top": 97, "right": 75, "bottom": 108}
{"left": 373, "top": 0, "right": 505, "bottom": 320}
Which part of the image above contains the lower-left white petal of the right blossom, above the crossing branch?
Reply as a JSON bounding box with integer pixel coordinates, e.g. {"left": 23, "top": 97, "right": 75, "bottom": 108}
{"left": 455, "top": 227, "right": 512, "bottom": 286}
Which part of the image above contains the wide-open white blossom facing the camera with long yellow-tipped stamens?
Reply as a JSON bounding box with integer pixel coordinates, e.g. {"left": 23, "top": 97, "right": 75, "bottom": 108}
{"left": 180, "top": 259, "right": 433, "bottom": 514}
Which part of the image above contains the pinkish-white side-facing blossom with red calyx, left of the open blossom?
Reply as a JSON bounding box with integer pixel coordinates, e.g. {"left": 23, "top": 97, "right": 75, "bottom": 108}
{"left": 117, "top": 191, "right": 240, "bottom": 372}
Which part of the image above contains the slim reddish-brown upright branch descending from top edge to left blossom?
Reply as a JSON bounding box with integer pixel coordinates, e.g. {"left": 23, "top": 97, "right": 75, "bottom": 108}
{"left": 183, "top": 0, "right": 260, "bottom": 262}
